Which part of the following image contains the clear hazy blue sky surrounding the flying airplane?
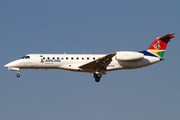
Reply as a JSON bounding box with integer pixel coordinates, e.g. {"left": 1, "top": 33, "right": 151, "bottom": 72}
{"left": 0, "top": 0, "right": 180, "bottom": 120}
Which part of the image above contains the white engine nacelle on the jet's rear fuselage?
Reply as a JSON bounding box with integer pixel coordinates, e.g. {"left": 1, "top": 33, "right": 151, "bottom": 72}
{"left": 115, "top": 51, "right": 144, "bottom": 61}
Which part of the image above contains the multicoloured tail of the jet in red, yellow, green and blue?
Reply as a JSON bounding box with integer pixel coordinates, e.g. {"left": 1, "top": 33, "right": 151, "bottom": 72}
{"left": 143, "top": 33, "right": 175, "bottom": 59}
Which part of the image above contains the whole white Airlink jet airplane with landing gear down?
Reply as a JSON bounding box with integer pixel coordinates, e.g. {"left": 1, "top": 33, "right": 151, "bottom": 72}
{"left": 4, "top": 33, "right": 175, "bottom": 82}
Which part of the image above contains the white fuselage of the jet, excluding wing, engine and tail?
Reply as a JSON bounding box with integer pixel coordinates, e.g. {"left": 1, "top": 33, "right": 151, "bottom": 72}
{"left": 5, "top": 54, "right": 160, "bottom": 73}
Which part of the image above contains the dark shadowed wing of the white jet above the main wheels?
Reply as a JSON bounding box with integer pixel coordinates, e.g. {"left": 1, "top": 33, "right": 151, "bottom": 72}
{"left": 79, "top": 53, "right": 116, "bottom": 69}
